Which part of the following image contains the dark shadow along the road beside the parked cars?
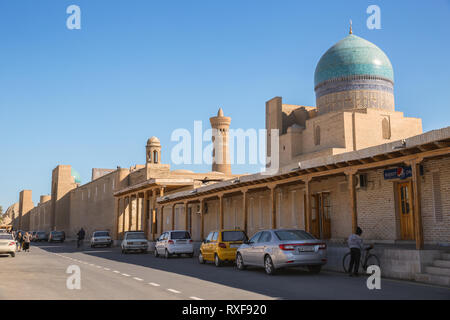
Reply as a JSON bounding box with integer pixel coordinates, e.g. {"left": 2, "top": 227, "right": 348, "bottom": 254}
{"left": 30, "top": 242, "right": 450, "bottom": 299}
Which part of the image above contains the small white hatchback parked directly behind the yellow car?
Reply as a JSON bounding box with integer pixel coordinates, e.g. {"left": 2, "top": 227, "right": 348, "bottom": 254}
{"left": 154, "top": 230, "right": 194, "bottom": 259}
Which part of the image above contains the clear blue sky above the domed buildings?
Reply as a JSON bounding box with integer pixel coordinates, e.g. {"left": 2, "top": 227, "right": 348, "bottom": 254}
{"left": 0, "top": 0, "right": 450, "bottom": 210}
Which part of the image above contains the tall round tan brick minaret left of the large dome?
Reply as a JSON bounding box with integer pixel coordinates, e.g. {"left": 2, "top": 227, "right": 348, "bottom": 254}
{"left": 209, "top": 108, "right": 231, "bottom": 174}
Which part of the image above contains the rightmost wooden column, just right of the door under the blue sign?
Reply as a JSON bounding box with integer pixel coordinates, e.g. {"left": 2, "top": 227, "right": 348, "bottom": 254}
{"left": 411, "top": 159, "right": 424, "bottom": 250}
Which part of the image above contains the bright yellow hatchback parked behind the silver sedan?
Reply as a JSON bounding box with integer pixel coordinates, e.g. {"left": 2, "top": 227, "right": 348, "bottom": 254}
{"left": 198, "top": 230, "right": 248, "bottom": 267}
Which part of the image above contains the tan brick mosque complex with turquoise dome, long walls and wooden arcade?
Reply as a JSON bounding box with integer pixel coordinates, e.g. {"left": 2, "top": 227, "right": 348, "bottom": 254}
{"left": 7, "top": 30, "right": 450, "bottom": 285}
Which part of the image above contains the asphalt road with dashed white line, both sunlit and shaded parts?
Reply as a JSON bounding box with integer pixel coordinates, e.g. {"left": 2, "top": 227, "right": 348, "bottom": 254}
{"left": 0, "top": 243, "right": 450, "bottom": 300}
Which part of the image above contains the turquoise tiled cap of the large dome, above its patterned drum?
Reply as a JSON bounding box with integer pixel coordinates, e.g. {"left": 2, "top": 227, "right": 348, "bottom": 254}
{"left": 314, "top": 34, "right": 394, "bottom": 87}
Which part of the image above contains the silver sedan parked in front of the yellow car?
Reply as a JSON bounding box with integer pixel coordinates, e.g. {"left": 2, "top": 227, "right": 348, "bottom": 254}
{"left": 236, "top": 229, "right": 327, "bottom": 274}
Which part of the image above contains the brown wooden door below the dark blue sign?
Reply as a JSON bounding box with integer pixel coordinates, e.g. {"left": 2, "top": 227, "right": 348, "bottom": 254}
{"left": 397, "top": 182, "right": 414, "bottom": 240}
